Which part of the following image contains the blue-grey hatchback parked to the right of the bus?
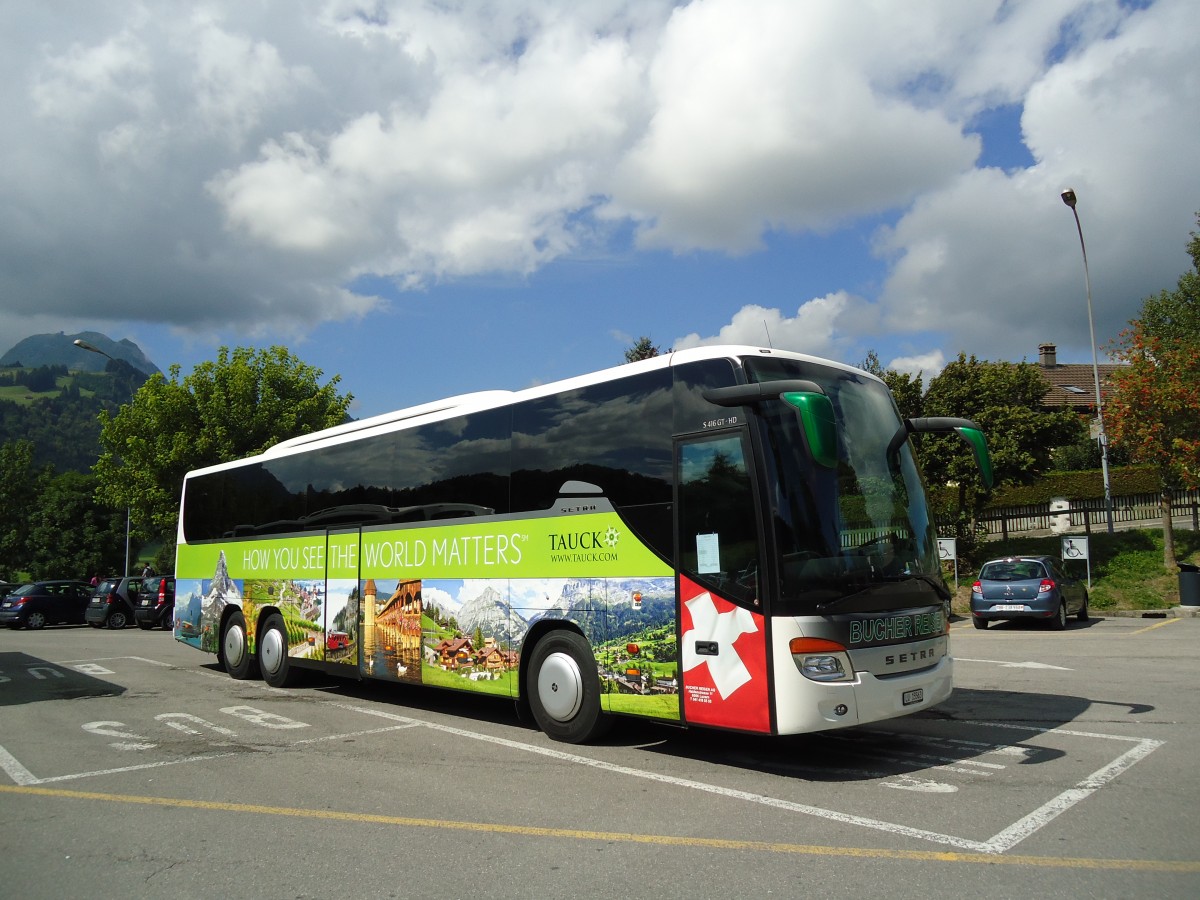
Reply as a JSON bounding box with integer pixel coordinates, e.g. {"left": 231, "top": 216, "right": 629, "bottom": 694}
{"left": 971, "top": 557, "right": 1087, "bottom": 629}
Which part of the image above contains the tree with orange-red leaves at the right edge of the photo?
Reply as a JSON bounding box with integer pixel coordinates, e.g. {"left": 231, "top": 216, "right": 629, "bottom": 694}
{"left": 1106, "top": 215, "right": 1200, "bottom": 570}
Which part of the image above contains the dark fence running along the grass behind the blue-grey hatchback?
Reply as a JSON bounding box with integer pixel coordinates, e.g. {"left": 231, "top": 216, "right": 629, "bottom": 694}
{"left": 979, "top": 490, "right": 1200, "bottom": 539}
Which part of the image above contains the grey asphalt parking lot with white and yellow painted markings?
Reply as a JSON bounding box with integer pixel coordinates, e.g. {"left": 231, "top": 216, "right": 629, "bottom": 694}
{"left": 0, "top": 618, "right": 1200, "bottom": 898}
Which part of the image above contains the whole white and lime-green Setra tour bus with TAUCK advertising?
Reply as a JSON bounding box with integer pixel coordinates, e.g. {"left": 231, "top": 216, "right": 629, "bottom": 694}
{"left": 174, "top": 347, "right": 991, "bottom": 742}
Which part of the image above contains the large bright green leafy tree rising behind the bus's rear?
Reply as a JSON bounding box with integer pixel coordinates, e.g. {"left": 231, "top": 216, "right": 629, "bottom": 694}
{"left": 94, "top": 347, "right": 353, "bottom": 538}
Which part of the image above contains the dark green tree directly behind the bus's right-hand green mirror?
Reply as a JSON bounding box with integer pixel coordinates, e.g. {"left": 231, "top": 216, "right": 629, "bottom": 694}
{"left": 918, "top": 353, "right": 1081, "bottom": 547}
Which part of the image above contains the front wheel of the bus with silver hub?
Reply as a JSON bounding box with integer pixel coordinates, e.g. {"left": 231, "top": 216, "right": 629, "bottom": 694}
{"left": 526, "top": 629, "right": 612, "bottom": 744}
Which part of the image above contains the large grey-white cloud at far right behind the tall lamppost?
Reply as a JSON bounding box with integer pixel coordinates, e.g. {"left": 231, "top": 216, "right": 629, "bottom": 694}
{"left": 662, "top": 0, "right": 1200, "bottom": 374}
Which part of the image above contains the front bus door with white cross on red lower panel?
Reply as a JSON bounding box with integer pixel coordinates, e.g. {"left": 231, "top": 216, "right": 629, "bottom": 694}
{"left": 676, "top": 428, "right": 770, "bottom": 732}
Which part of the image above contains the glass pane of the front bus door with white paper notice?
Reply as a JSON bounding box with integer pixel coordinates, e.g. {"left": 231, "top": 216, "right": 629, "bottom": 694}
{"left": 678, "top": 432, "right": 758, "bottom": 605}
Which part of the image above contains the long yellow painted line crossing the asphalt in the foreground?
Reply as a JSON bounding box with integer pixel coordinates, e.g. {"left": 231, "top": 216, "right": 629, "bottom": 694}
{"left": 0, "top": 785, "right": 1200, "bottom": 874}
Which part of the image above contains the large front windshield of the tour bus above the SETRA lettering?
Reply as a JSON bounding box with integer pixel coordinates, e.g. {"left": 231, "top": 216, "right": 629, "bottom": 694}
{"left": 746, "top": 359, "right": 949, "bottom": 614}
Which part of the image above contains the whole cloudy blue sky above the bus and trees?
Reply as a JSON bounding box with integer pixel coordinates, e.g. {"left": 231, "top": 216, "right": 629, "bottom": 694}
{"left": 0, "top": 0, "right": 1200, "bottom": 416}
